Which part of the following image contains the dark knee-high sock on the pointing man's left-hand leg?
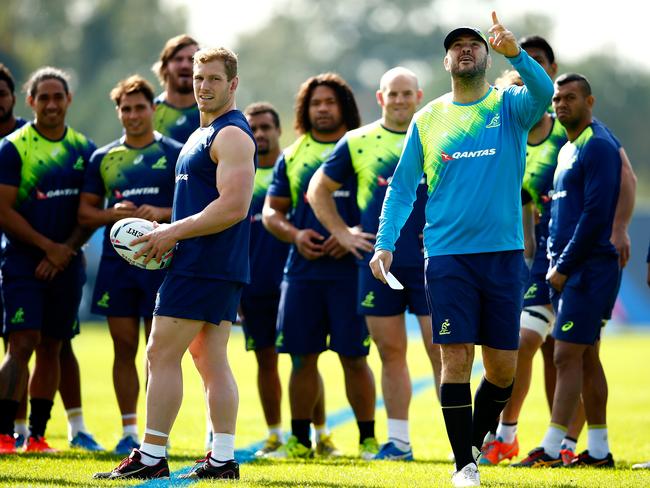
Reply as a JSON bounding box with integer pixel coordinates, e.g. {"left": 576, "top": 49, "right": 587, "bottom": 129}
{"left": 440, "top": 383, "right": 476, "bottom": 470}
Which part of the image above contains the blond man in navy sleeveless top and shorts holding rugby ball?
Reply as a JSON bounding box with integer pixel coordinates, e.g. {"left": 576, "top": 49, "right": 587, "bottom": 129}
{"left": 95, "top": 48, "right": 257, "bottom": 479}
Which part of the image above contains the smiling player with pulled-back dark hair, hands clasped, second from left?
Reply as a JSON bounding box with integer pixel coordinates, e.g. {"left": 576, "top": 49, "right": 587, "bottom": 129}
{"left": 0, "top": 67, "right": 96, "bottom": 453}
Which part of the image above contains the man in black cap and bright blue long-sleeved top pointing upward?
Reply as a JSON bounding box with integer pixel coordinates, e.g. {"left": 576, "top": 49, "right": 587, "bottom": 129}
{"left": 370, "top": 12, "right": 552, "bottom": 486}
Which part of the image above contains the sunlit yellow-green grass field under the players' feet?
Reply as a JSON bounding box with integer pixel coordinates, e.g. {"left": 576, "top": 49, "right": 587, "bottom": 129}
{"left": 0, "top": 324, "right": 650, "bottom": 488}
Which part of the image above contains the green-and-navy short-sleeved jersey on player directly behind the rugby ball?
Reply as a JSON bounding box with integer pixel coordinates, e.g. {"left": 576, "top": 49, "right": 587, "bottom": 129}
{"left": 81, "top": 132, "right": 183, "bottom": 257}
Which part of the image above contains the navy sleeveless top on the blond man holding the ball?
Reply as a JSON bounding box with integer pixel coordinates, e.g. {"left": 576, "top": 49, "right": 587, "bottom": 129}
{"left": 169, "top": 110, "right": 257, "bottom": 283}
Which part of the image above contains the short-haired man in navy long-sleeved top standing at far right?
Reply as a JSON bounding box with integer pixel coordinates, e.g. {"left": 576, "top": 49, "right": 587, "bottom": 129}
{"left": 516, "top": 73, "right": 621, "bottom": 467}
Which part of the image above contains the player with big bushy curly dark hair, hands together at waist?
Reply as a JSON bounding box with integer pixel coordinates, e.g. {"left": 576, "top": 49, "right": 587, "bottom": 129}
{"left": 262, "top": 73, "right": 376, "bottom": 458}
